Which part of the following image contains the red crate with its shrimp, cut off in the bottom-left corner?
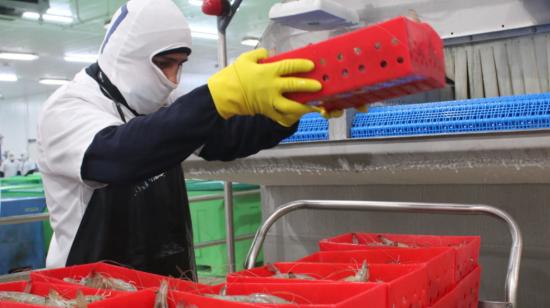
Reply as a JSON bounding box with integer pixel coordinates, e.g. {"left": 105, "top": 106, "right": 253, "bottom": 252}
{"left": 0, "top": 281, "right": 134, "bottom": 308}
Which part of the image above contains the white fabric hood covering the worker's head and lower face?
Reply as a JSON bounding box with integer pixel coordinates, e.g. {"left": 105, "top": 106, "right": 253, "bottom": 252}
{"left": 98, "top": 0, "right": 191, "bottom": 114}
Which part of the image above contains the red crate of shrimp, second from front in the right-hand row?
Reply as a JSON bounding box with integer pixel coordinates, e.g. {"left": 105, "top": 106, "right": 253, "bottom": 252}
{"left": 227, "top": 261, "right": 429, "bottom": 307}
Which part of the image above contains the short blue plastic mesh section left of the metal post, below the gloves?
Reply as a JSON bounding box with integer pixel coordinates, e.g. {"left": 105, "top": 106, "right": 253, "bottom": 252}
{"left": 281, "top": 113, "right": 328, "bottom": 143}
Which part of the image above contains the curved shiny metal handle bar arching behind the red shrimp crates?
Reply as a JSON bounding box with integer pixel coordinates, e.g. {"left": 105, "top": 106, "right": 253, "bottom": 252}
{"left": 245, "top": 200, "right": 523, "bottom": 307}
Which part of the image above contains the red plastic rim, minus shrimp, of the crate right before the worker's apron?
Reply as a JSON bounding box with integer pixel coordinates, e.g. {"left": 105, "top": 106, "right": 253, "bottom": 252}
{"left": 31, "top": 262, "right": 207, "bottom": 291}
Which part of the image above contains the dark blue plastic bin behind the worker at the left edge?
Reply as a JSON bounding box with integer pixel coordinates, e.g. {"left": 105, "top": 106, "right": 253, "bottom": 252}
{"left": 0, "top": 198, "right": 46, "bottom": 275}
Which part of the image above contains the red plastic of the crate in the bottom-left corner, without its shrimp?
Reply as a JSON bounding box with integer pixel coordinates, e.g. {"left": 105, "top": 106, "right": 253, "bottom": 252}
{"left": 0, "top": 281, "right": 126, "bottom": 308}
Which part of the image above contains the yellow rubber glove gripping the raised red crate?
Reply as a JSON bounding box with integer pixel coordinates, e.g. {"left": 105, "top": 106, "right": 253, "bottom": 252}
{"left": 208, "top": 48, "right": 322, "bottom": 127}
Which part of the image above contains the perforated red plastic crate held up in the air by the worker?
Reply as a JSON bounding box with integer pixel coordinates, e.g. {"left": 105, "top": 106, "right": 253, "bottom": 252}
{"left": 265, "top": 17, "right": 445, "bottom": 111}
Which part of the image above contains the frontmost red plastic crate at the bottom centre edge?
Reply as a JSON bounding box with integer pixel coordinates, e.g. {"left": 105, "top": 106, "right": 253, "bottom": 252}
{"left": 188, "top": 283, "right": 390, "bottom": 308}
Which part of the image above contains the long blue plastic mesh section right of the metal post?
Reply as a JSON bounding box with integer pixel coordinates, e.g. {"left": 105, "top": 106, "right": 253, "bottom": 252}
{"left": 351, "top": 93, "right": 550, "bottom": 138}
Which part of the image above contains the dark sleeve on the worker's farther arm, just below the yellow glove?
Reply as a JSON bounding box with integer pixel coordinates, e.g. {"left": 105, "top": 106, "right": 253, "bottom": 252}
{"left": 199, "top": 115, "right": 298, "bottom": 161}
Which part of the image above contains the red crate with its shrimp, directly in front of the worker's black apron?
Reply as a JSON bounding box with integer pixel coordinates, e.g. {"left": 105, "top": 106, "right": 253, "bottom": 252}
{"left": 31, "top": 262, "right": 206, "bottom": 292}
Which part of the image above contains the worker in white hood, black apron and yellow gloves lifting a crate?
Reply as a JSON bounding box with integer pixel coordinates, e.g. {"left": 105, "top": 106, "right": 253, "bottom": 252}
{"left": 38, "top": 0, "right": 332, "bottom": 279}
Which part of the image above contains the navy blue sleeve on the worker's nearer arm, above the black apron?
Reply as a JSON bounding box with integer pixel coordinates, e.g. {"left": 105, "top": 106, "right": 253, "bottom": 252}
{"left": 81, "top": 86, "right": 224, "bottom": 184}
